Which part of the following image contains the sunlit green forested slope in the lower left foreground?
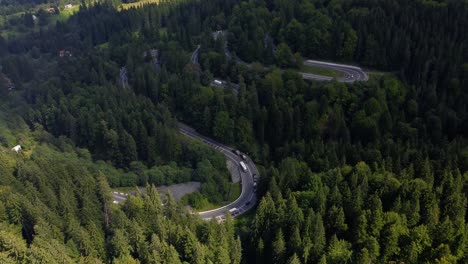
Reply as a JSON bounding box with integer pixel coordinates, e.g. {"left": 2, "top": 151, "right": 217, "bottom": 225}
{"left": 0, "top": 106, "right": 241, "bottom": 263}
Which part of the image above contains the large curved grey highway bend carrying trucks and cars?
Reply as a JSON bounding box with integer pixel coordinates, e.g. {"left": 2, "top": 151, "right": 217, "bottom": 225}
{"left": 179, "top": 123, "right": 259, "bottom": 222}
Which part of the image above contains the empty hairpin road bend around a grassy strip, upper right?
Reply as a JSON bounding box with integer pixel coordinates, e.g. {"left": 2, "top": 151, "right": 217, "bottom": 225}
{"left": 301, "top": 60, "right": 369, "bottom": 83}
